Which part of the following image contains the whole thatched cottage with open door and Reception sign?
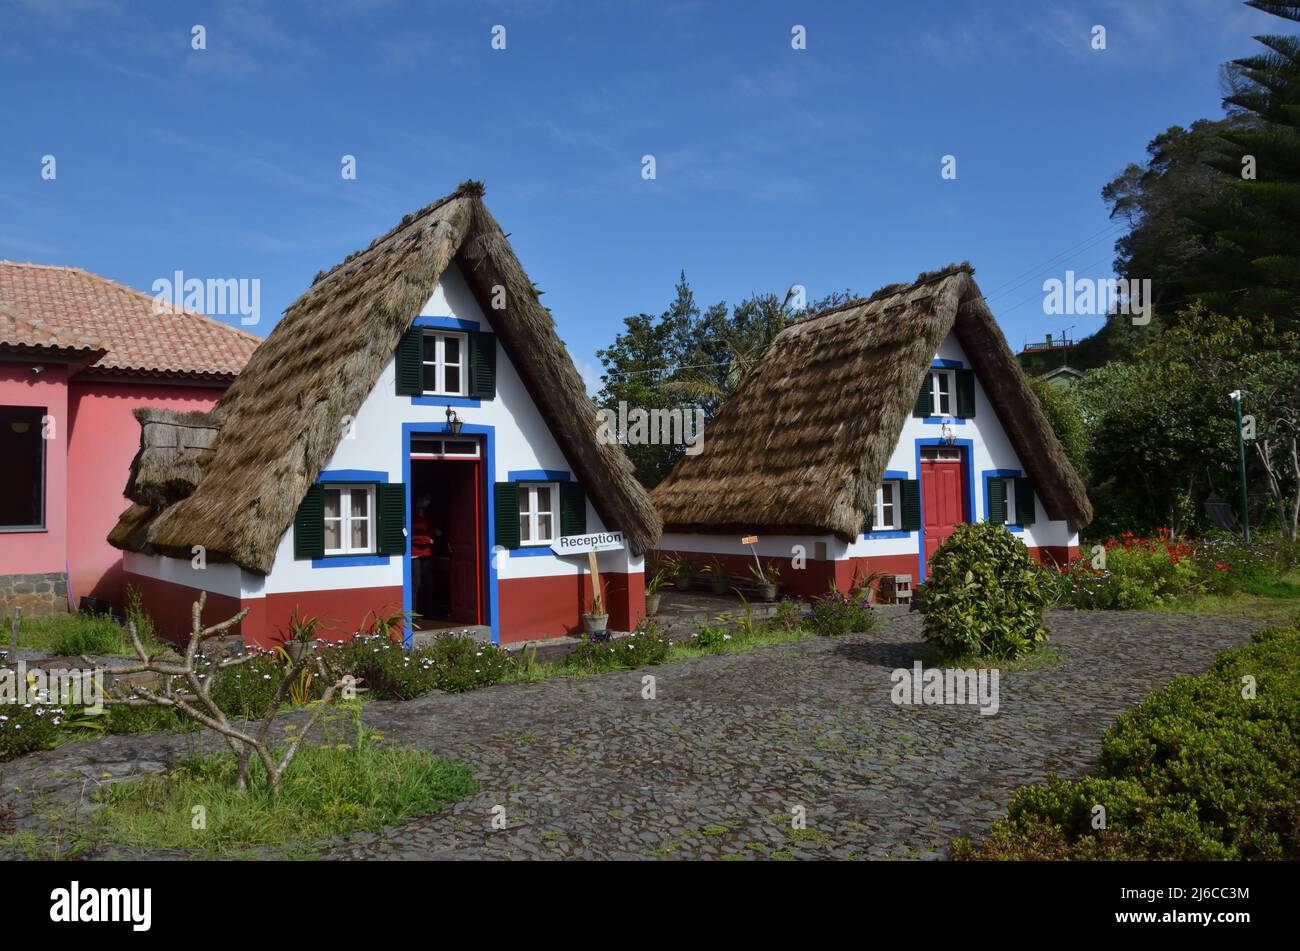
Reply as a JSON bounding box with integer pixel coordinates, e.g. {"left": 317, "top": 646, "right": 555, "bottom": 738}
{"left": 111, "top": 182, "right": 660, "bottom": 644}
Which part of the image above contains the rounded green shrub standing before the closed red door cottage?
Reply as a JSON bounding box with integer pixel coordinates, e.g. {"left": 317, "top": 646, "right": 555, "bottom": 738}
{"left": 922, "top": 522, "right": 1052, "bottom": 657}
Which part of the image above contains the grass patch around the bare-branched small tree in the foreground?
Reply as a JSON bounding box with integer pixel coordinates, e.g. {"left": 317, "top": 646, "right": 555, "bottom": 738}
{"left": 92, "top": 711, "right": 478, "bottom": 857}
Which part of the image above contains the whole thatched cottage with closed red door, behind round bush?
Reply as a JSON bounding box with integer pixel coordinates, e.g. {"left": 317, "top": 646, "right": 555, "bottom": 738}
{"left": 651, "top": 265, "right": 1092, "bottom": 595}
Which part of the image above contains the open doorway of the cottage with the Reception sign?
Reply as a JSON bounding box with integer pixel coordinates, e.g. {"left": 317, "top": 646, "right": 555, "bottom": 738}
{"left": 411, "top": 434, "right": 486, "bottom": 630}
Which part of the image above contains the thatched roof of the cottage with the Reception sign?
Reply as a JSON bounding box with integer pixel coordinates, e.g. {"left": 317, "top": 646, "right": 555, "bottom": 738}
{"left": 109, "top": 182, "right": 660, "bottom": 573}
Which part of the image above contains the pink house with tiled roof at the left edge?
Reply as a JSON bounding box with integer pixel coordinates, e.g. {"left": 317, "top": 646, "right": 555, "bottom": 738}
{"left": 0, "top": 261, "right": 260, "bottom": 615}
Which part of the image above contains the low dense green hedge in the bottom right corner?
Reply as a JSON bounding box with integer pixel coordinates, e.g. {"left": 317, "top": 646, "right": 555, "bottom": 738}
{"left": 953, "top": 629, "right": 1300, "bottom": 860}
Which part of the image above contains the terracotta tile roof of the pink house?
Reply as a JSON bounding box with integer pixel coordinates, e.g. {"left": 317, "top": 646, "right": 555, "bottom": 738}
{"left": 0, "top": 261, "right": 261, "bottom": 378}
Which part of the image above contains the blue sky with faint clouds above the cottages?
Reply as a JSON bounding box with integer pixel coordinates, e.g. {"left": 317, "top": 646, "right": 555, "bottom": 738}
{"left": 0, "top": 0, "right": 1287, "bottom": 387}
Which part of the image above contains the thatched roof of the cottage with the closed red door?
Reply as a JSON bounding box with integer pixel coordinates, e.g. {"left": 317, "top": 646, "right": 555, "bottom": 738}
{"left": 650, "top": 264, "right": 1092, "bottom": 539}
